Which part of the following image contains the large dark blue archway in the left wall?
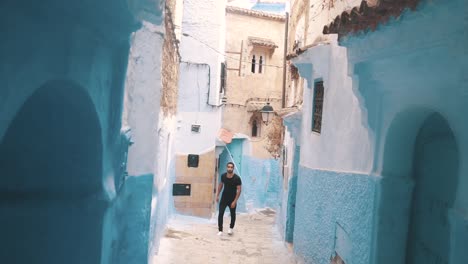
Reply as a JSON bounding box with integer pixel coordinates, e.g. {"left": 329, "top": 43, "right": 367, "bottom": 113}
{"left": 0, "top": 81, "right": 106, "bottom": 264}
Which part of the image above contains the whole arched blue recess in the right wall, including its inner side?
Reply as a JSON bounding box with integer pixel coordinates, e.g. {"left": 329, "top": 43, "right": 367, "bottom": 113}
{"left": 376, "top": 110, "right": 459, "bottom": 263}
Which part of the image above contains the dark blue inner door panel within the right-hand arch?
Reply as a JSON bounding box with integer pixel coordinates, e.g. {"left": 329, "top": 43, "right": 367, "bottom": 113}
{"left": 406, "top": 114, "right": 458, "bottom": 264}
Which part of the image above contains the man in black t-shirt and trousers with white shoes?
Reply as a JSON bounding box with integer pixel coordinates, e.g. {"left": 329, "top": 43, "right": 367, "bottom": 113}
{"left": 216, "top": 162, "right": 242, "bottom": 236}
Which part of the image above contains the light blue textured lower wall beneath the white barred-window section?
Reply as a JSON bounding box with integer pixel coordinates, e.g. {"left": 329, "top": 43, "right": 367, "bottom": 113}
{"left": 294, "top": 166, "right": 376, "bottom": 264}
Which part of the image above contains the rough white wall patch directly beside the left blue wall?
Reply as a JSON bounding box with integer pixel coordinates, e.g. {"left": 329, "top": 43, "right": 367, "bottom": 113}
{"left": 122, "top": 22, "right": 163, "bottom": 176}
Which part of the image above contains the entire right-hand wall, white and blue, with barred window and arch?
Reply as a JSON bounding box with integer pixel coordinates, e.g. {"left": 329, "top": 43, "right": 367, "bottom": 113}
{"left": 293, "top": 0, "right": 468, "bottom": 264}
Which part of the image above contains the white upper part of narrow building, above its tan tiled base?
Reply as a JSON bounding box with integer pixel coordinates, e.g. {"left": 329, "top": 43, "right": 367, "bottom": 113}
{"left": 175, "top": 0, "right": 226, "bottom": 154}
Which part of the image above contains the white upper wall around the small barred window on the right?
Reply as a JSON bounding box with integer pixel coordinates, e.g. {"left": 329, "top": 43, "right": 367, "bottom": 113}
{"left": 293, "top": 36, "right": 373, "bottom": 173}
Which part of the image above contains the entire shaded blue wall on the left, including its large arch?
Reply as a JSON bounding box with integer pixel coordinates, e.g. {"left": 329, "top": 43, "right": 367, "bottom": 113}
{"left": 0, "top": 0, "right": 165, "bottom": 264}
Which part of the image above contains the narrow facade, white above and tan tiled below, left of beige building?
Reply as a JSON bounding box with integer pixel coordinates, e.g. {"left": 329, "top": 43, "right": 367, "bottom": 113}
{"left": 173, "top": 0, "right": 226, "bottom": 217}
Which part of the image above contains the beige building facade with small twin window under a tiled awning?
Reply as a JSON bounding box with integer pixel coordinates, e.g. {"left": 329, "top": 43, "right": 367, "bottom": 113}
{"left": 223, "top": 6, "right": 285, "bottom": 159}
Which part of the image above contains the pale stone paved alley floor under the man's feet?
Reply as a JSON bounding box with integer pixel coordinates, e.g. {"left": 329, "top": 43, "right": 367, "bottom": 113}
{"left": 153, "top": 209, "right": 296, "bottom": 264}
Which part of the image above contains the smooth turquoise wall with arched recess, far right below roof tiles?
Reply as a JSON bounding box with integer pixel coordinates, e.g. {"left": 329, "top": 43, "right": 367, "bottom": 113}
{"left": 342, "top": 0, "right": 468, "bottom": 264}
